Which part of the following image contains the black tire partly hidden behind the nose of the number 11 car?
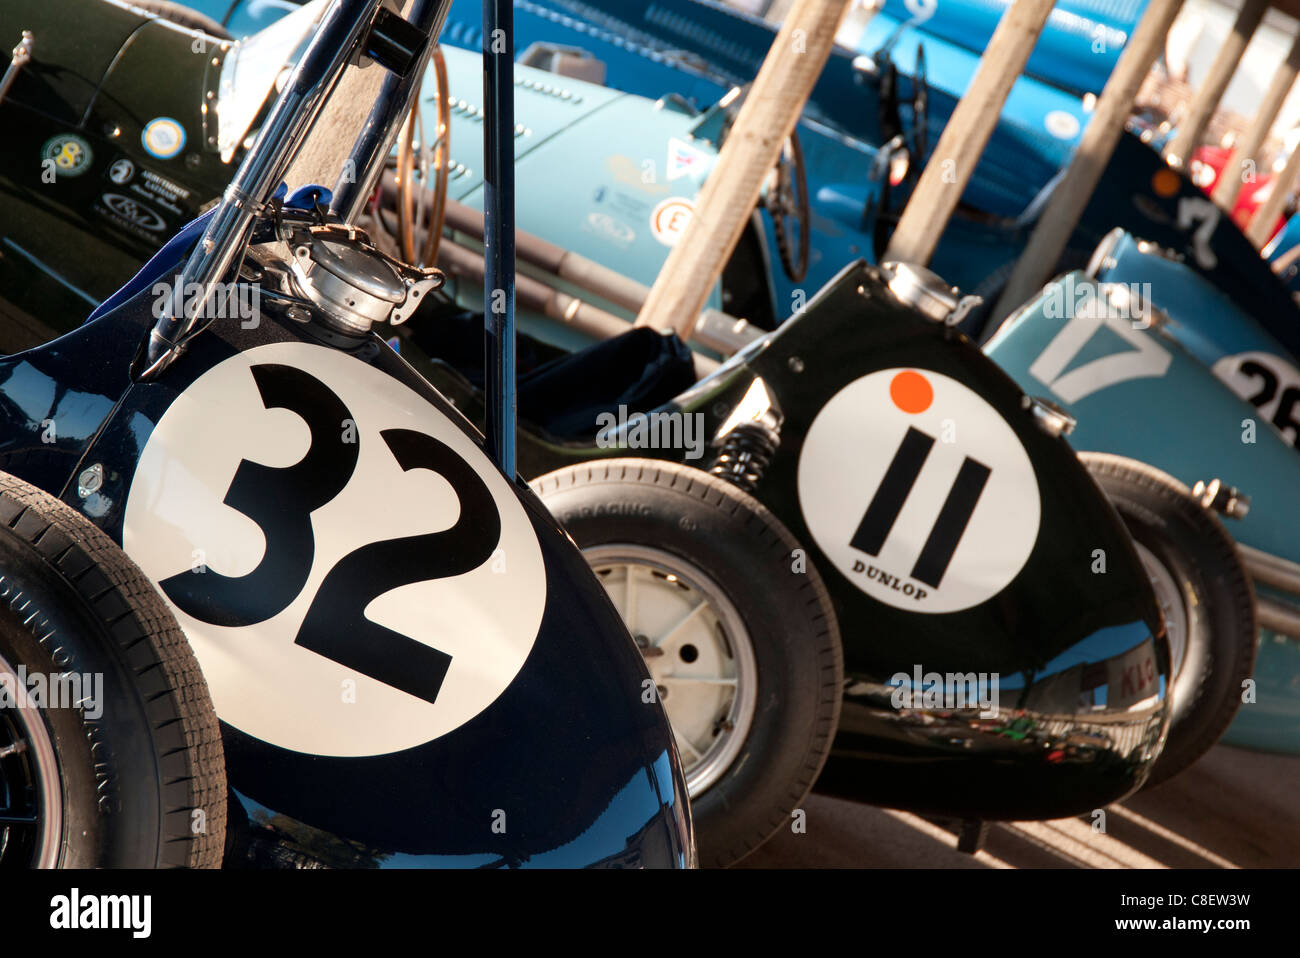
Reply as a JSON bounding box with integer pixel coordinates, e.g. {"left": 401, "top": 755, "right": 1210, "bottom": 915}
{"left": 1079, "top": 452, "right": 1256, "bottom": 786}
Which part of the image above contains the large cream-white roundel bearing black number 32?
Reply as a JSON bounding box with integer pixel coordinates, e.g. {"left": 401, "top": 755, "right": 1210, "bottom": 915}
{"left": 124, "top": 343, "right": 546, "bottom": 757}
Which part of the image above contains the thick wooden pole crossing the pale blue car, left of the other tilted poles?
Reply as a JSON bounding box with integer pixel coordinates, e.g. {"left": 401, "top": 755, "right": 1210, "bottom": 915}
{"left": 637, "top": 0, "right": 853, "bottom": 338}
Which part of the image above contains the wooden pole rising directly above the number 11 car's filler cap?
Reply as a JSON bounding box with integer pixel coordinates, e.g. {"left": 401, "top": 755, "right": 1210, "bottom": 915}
{"left": 884, "top": 0, "right": 1054, "bottom": 265}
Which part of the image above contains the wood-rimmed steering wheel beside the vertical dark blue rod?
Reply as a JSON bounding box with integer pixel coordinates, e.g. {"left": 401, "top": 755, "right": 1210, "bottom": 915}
{"left": 397, "top": 47, "right": 451, "bottom": 266}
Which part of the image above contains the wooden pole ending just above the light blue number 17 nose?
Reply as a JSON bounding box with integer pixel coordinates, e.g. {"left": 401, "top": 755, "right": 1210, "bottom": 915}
{"left": 993, "top": 0, "right": 1183, "bottom": 318}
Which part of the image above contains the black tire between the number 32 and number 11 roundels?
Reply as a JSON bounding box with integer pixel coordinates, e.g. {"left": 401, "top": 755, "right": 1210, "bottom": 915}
{"left": 533, "top": 459, "right": 844, "bottom": 867}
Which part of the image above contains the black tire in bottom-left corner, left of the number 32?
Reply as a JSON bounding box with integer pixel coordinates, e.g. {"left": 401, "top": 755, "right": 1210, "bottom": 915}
{"left": 0, "top": 474, "right": 226, "bottom": 868}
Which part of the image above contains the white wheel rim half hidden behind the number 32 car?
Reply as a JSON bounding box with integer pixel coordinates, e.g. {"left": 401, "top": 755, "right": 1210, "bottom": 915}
{"left": 582, "top": 543, "right": 758, "bottom": 798}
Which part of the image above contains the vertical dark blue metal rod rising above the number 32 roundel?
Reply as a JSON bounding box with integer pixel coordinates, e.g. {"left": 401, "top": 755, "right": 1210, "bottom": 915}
{"left": 482, "top": 0, "right": 516, "bottom": 480}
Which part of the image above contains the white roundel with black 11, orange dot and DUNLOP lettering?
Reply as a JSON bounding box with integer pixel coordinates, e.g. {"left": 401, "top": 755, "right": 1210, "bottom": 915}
{"left": 798, "top": 369, "right": 1040, "bottom": 612}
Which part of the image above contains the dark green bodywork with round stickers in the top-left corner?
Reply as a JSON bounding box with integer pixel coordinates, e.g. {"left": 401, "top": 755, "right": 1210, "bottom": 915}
{"left": 0, "top": 0, "right": 233, "bottom": 352}
